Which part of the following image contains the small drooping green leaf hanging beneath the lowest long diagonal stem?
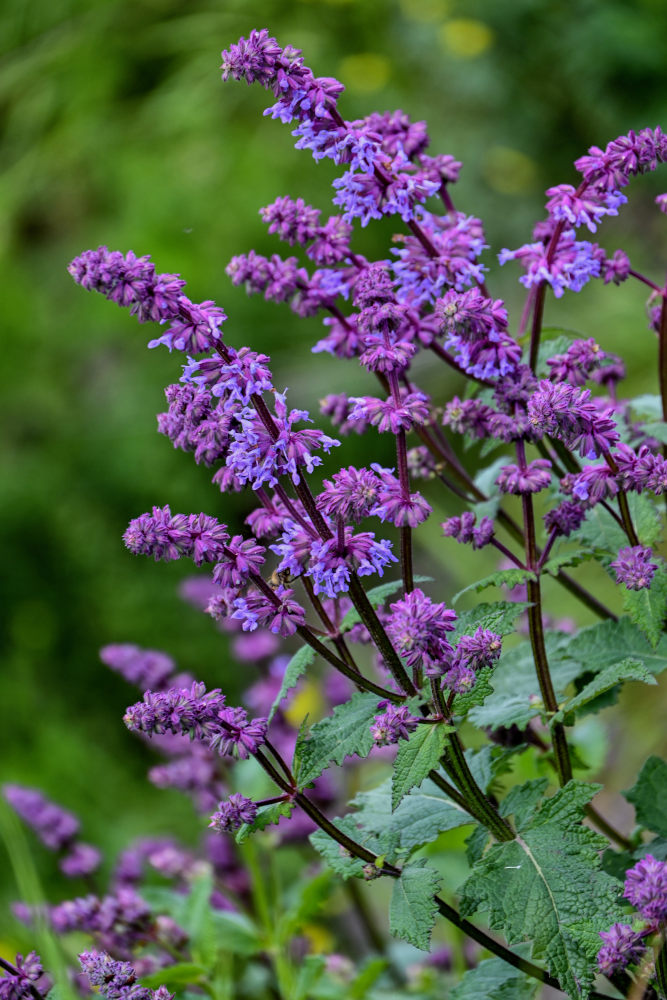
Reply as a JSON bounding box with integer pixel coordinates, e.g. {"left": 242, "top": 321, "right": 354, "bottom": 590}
{"left": 389, "top": 858, "right": 441, "bottom": 951}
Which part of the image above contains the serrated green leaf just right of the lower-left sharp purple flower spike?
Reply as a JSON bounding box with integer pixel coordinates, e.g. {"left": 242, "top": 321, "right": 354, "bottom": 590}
{"left": 299, "top": 692, "right": 378, "bottom": 789}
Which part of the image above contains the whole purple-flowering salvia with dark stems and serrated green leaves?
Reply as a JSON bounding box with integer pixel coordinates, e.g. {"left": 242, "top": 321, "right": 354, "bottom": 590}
{"left": 5, "top": 21, "right": 667, "bottom": 1000}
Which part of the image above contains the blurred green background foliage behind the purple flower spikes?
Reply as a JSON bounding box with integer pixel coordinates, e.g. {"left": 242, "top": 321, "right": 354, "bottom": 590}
{"left": 0, "top": 0, "right": 667, "bottom": 927}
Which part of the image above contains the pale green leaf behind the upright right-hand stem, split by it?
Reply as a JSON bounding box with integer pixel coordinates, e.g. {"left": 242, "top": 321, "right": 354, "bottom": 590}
{"left": 468, "top": 632, "right": 584, "bottom": 729}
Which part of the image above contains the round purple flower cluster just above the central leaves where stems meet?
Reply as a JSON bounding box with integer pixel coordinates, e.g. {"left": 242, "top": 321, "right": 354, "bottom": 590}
{"left": 386, "top": 588, "right": 456, "bottom": 676}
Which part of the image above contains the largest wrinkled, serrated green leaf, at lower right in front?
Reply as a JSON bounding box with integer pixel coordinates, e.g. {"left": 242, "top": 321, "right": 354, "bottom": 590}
{"left": 461, "top": 781, "right": 624, "bottom": 998}
